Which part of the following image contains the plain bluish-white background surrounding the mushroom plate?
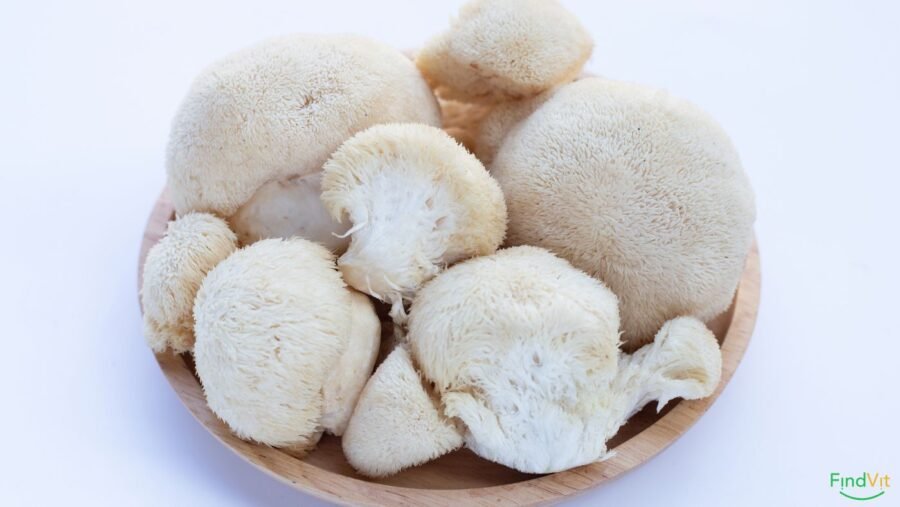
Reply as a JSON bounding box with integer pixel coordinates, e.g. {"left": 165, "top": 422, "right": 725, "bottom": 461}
{"left": 0, "top": 0, "right": 900, "bottom": 506}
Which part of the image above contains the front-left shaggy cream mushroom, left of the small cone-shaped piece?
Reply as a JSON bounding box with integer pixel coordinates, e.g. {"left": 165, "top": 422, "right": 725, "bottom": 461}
{"left": 194, "top": 238, "right": 380, "bottom": 451}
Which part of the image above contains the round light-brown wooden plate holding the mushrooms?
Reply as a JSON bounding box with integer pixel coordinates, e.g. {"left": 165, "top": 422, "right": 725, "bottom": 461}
{"left": 138, "top": 192, "right": 760, "bottom": 506}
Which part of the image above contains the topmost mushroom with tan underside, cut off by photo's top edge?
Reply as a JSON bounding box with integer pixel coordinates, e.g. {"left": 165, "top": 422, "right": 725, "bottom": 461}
{"left": 416, "top": 0, "right": 593, "bottom": 102}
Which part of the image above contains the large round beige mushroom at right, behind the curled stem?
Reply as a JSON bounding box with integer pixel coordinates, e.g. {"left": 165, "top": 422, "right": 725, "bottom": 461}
{"left": 491, "top": 78, "right": 755, "bottom": 346}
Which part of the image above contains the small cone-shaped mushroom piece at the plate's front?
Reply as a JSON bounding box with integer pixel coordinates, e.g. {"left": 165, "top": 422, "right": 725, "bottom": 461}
{"left": 342, "top": 346, "right": 463, "bottom": 477}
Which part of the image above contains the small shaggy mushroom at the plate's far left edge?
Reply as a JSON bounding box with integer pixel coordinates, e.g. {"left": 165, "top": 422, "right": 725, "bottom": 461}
{"left": 141, "top": 213, "right": 237, "bottom": 353}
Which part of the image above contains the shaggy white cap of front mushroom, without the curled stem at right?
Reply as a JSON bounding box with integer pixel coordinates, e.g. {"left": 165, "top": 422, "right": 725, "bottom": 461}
{"left": 408, "top": 247, "right": 619, "bottom": 473}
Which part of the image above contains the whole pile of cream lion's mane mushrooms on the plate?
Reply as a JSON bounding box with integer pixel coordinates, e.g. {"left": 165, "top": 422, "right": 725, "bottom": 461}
{"left": 141, "top": 0, "right": 755, "bottom": 477}
